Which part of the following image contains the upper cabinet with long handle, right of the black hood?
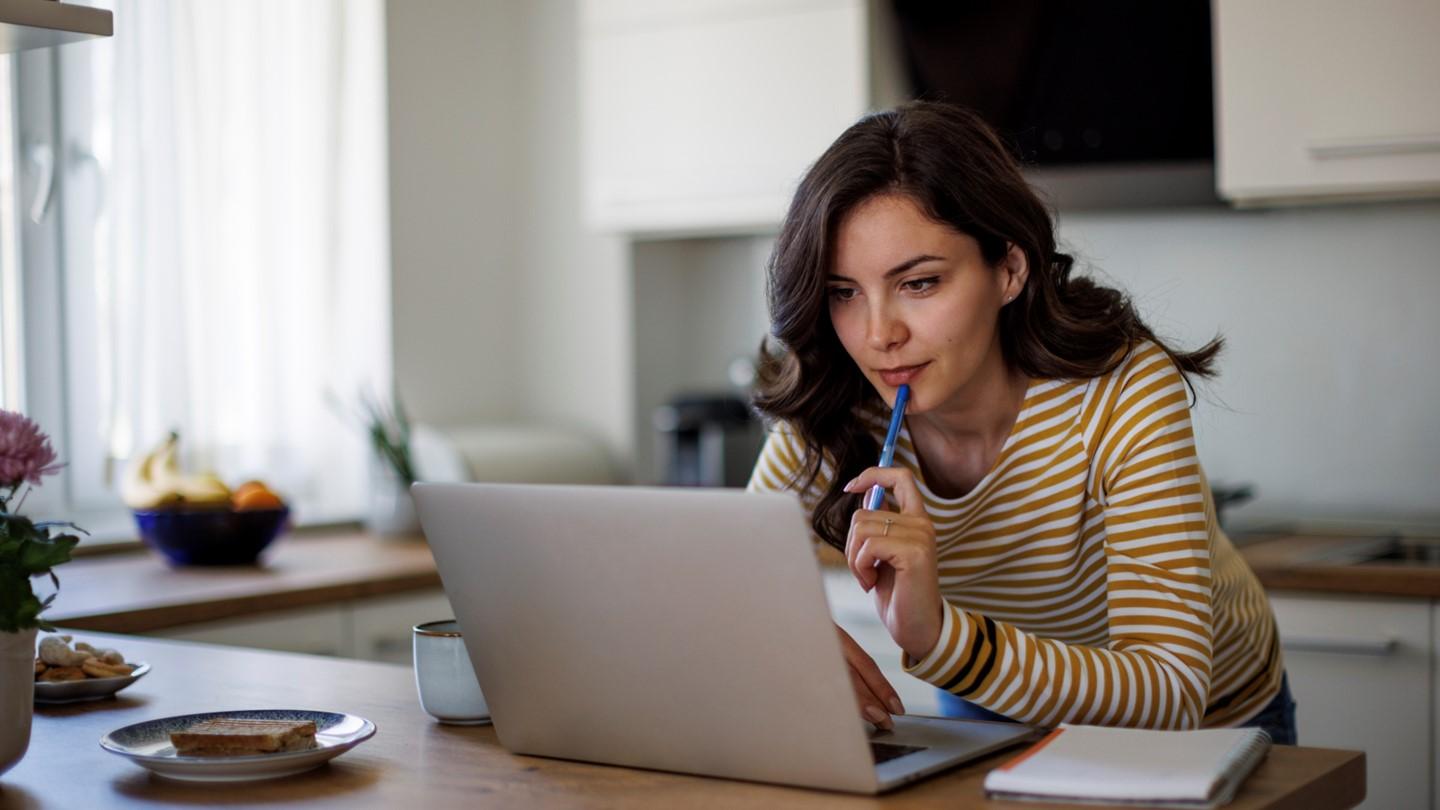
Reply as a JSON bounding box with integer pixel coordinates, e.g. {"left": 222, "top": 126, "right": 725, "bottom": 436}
{"left": 1212, "top": 0, "right": 1440, "bottom": 205}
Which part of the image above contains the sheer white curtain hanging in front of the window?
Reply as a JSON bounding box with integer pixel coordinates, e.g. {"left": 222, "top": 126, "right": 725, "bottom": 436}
{"left": 72, "top": 0, "right": 390, "bottom": 519}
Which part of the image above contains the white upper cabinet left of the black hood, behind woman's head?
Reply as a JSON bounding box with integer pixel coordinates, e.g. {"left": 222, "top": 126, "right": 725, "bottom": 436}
{"left": 580, "top": 0, "right": 870, "bottom": 233}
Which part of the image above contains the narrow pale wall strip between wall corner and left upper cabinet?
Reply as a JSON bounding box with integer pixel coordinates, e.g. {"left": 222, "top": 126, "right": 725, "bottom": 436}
{"left": 511, "top": 0, "right": 634, "bottom": 471}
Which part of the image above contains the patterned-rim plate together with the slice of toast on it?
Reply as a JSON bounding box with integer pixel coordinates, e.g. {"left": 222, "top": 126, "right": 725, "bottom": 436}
{"left": 99, "top": 709, "right": 374, "bottom": 781}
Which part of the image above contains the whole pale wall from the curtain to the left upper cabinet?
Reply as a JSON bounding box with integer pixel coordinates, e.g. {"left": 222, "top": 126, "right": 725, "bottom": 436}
{"left": 386, "top": 0, "right": 632, "bottom": 471}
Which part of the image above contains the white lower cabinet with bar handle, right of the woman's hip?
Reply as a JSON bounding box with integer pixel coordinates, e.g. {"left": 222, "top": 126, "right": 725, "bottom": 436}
{"left": 1270, "top": 592, "right": 1434, "bottom": 810}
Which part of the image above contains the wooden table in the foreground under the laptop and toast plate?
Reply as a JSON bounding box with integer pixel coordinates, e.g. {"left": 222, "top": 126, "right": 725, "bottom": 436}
{"left": 0, "top": 633, "right": 1365, "bottom": 810}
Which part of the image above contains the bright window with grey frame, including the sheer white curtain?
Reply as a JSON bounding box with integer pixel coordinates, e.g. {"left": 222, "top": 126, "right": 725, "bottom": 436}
{"left": 0, "top": 6, "right": 390, "bottom": 533}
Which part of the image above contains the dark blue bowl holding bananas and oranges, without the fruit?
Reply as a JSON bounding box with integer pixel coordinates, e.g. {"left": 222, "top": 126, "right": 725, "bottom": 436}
{"left": 135, "top": 506, "right": 289, "bottom": 565}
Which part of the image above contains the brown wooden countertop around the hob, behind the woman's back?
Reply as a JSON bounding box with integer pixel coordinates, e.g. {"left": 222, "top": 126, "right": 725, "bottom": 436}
{"left": 1240, "top": 535, "right": 1440, "bottom": 598}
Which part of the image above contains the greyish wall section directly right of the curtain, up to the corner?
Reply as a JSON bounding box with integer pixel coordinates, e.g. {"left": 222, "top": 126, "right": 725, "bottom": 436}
{"left": 386, "top": 0, "right": 526, "bottom": 422}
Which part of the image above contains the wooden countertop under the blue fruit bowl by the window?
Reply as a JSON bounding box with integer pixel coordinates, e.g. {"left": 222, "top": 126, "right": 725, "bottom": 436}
{"left": 45, "top": 532, "right": 441, "bottom": 633}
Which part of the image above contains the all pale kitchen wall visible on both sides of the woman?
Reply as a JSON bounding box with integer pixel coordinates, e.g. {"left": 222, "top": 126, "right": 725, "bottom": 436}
{"left": 389, "top": 0, "right": 1440, "bottom": 529}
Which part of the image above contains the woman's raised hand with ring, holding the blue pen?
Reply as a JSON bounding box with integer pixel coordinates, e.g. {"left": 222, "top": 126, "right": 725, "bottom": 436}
{"left": 845, "top": 467, "right": 945, "bottom": 659}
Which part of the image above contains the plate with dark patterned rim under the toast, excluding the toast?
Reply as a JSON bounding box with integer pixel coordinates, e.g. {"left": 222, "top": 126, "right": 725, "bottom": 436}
{"left": 99, "top": 709, "right": 374, "bottom": 781}
